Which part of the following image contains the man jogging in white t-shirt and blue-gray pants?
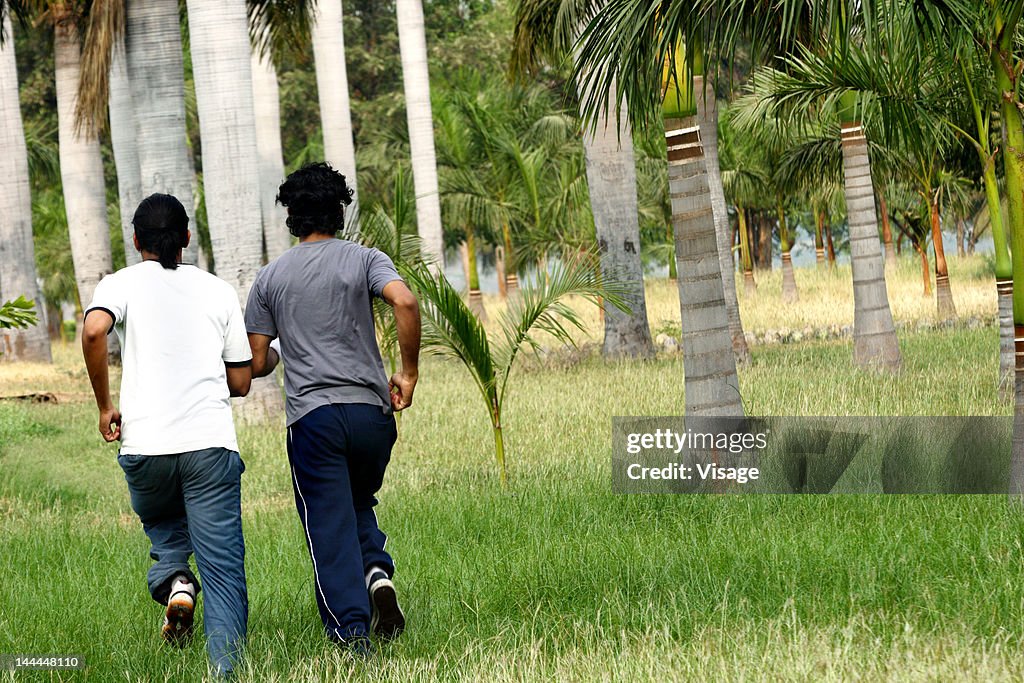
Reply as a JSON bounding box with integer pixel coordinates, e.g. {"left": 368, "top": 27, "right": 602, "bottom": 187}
{"left": 82, "top": 195, "right": 252, "bottom": 675}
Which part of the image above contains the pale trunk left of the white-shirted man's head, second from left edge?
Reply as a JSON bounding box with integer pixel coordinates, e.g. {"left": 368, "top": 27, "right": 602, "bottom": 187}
{"left": 53, "top": 17, "right": 114, "bottom": 308}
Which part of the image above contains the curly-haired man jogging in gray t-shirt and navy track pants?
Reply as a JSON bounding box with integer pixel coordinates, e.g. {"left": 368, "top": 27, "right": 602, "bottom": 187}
{"left": 246, "top": 164, "right": 420, "bottom": 652}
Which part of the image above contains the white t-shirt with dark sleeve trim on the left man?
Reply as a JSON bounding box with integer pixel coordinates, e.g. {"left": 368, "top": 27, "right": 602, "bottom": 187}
{"left": 86, "top": 261, "right": 252, "bottom": 456}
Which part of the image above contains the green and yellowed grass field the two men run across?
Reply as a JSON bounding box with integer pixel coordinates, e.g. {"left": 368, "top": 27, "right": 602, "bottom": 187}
{"left": 0, "top": 259, "right": 1024, "bottom": 681}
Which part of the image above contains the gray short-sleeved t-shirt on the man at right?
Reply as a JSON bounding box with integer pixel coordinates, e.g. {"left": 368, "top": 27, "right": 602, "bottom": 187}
{"left": 246, "top": 239, "right": 400, "bottom": 426}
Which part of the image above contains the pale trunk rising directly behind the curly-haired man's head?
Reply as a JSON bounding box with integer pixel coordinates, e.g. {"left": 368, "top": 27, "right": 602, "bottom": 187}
{"left": 309, "top": 0, "right": 358, "bottom": 224}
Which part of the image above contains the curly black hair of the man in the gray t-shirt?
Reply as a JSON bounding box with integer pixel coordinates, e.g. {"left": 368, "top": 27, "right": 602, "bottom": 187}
{"left": 278, "top": 162, "right": 352, "bottom": 238}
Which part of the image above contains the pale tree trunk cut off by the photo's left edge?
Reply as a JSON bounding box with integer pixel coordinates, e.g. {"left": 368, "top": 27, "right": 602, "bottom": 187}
{"left": 0, "top": 14, "right": 52, "bottom": 362}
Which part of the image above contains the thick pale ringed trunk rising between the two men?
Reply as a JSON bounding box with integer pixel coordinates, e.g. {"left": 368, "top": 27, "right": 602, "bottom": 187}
{"left": 187, "top": 0, "right": 284, "bottom": 422}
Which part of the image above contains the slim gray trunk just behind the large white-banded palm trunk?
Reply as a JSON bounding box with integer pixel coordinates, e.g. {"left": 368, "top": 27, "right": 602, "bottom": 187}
{"left": 693, "top": 76, "right": 751, "bottom": 364}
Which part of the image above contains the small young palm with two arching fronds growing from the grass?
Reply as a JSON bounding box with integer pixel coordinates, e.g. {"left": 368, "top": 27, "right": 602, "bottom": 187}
{"left": 403, "top": 258, "right": 623, "bottom": 485}
